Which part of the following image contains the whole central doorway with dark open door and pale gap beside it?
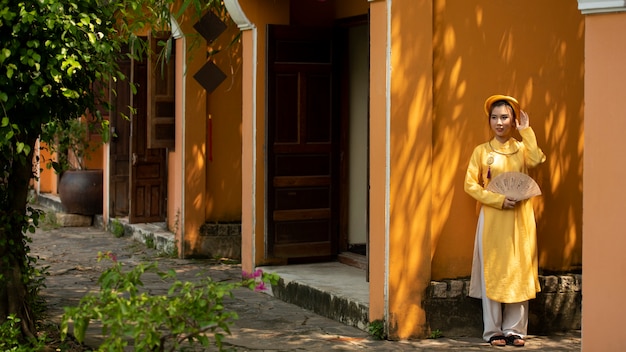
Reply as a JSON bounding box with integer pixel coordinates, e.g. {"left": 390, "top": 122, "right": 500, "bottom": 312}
{"left": 266, "top": 15, "right": 369, "bottom": 269}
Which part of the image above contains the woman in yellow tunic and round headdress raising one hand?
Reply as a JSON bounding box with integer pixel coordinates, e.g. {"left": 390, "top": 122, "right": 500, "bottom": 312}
{"left": 465, "top": 95, "right": 546, "bottom": 346}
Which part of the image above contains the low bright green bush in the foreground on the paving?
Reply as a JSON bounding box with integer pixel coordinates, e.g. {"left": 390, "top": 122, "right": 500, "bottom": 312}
{"left": 61, "top": 252, "right": 278, "bottom": 351}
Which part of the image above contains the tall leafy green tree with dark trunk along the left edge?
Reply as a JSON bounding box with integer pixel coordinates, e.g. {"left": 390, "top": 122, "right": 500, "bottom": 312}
{"left": 0, "top": 0, "right": 229, "bottom": 339}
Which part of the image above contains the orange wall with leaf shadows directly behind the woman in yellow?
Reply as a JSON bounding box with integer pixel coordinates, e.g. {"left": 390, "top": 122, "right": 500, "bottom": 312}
{"left": 432, "top": 0, "right": 584, "bottom": 279}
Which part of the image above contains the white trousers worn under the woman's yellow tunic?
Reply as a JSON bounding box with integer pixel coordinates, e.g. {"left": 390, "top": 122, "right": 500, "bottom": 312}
{"left": 476, "top": 209, "right": 528, "bottom": 341}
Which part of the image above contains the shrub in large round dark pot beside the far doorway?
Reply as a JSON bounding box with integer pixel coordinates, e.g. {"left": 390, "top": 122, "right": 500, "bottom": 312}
{"left": 44, "top": 118, "right": 108, "bottom": 215}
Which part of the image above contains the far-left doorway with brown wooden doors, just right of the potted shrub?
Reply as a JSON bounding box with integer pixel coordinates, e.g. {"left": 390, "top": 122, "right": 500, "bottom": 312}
{"left": 109, "top": 39, "right": 167, "bottom": 223}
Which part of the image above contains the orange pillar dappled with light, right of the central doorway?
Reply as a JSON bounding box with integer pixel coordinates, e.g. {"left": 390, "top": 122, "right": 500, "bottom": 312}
{"left": 370, "top": 0, "right": 433, "bottom": 339}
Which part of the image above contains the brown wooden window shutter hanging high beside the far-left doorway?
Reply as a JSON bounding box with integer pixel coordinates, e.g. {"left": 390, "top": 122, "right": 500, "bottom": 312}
{"left": 147, "top": 32, "right": 176, "bottom": 149}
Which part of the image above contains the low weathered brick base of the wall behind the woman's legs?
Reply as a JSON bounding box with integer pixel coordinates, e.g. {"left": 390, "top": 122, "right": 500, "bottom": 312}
{"left": 424, "top": 274, "right": 582, "bottom": 336}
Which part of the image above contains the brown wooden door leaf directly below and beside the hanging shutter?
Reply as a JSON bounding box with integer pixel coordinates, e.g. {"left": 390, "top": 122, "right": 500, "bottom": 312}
{"left": 129, "top": 57, "right": 167, "bottom": 223}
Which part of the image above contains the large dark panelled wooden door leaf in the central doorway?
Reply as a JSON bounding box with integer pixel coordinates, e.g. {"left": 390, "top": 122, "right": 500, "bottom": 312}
{"left": 267, "top": 25, "right": 339, "bottom": 259}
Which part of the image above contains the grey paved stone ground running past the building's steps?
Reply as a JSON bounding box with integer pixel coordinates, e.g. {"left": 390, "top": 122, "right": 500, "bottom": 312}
{"left": 31, "top": 227, "right": 581, "bottom": 351}
